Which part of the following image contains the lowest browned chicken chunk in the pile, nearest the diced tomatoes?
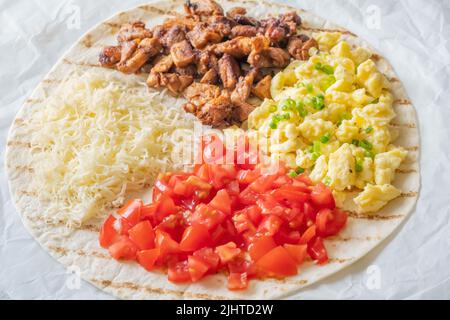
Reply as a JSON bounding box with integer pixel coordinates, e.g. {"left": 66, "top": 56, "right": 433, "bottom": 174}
{"left": 197, "top": 92, "right": 233, "bottom": 127}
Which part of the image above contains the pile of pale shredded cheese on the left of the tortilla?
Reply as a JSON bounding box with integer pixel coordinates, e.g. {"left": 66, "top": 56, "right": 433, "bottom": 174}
{"left": 30, "top": 72, "right": 194, "bottom": 225}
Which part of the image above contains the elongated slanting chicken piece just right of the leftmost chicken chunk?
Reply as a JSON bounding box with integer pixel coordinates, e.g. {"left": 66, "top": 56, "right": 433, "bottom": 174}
{"left": 117, "top": 38, "right": 162, "bottom": 73}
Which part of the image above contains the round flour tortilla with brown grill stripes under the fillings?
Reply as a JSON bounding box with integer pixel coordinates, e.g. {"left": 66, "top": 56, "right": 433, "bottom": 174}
{"left": 6, "top": 0, "right": 420, "bottom": 299}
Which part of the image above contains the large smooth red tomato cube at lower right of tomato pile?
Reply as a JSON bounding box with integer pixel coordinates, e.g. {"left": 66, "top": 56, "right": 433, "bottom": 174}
{"left": 256, "top": 246, "right": 297, "bottom": 277}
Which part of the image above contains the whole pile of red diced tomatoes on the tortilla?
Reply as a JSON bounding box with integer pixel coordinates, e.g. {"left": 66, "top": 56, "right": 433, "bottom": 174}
{"left": 99, "top": 134, "right": 347, "bottom": 290}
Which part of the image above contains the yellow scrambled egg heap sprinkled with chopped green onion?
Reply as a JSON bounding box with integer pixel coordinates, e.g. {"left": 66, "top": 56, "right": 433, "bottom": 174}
{"left": 248, "top": 32, "right": 407, "bottom": 213}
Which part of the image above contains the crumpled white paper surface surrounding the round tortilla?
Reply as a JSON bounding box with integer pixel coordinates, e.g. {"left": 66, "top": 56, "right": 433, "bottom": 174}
{"left": 0, "top": 0, "right": 450, "bottom": 299}
